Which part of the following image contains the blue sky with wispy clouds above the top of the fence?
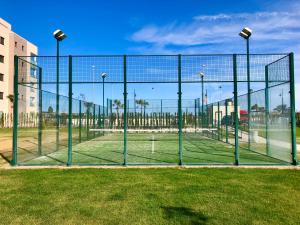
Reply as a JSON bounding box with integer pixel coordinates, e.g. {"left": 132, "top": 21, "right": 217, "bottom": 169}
{"left": 0, "top": 0, "right": 300, "bottom": 109}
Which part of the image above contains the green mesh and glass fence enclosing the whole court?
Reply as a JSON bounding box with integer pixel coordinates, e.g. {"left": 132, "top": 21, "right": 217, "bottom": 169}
{"left": 12, "top": 54, "right": 297, "bottom": 165}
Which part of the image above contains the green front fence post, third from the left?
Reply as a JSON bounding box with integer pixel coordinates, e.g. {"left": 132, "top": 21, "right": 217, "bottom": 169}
{"left": 123, "top": 55, "right": 127, "bottom": 166}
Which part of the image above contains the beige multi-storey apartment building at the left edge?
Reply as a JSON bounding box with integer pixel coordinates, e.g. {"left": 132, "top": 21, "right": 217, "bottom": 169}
{"left": 0, "top": 18, "right": 38, "bottom": 113}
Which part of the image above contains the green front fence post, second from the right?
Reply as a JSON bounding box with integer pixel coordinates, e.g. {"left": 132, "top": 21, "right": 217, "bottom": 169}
{"left": 233, "top": 54, "right": 239, "bottom": 165}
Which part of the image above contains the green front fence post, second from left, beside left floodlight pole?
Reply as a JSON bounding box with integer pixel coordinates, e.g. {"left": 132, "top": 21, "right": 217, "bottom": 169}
{"left": 67, "top": 56, "right": 73, "bottom": 166}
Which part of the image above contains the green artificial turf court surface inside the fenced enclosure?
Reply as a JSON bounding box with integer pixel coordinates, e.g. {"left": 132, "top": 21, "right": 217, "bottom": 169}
{"left": 19, "top": 132, "right": 288, "bottom": 165}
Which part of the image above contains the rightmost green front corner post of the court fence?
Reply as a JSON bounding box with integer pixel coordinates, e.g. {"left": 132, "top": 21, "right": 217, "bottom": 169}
{"left": 289, "top": 53, "right": 298, "bottom": 165}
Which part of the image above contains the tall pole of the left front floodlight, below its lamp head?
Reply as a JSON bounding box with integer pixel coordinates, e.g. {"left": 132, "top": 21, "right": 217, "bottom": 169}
{"left": 55, "top": 39, "right": 59, "bottom": 151}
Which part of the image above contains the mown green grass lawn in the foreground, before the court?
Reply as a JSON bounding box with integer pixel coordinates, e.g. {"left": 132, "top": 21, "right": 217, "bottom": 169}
{"left": 0, "top": 168, "right": 300, "bottom": 225}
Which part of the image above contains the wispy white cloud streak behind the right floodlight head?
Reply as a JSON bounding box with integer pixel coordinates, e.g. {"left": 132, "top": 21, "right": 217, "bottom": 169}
{"left": 131, "top": 12, "right": 300, "bottom": 46}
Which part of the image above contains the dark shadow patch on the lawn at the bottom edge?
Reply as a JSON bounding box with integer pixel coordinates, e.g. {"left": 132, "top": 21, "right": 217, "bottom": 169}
{"left": 162, "top": 206, "right": 208, "bottom": 225}
